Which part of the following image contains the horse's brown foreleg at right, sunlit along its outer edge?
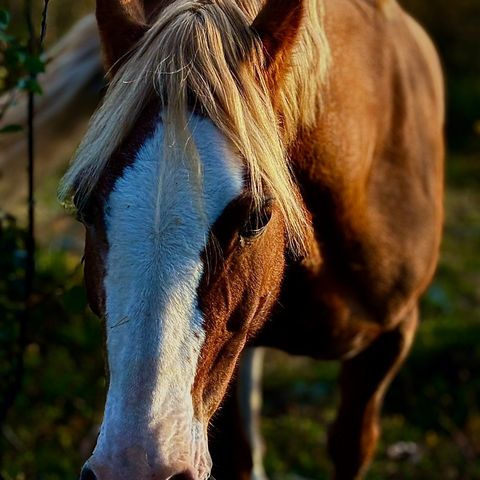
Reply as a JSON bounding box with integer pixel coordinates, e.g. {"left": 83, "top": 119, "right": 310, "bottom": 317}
{"left": 329, "top": 308, "right": 418, "bottom": 480}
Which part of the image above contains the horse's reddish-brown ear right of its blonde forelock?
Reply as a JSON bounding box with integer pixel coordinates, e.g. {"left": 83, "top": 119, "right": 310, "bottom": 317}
{"left": 252, "top": 0, "right": 304, "bottom": 66}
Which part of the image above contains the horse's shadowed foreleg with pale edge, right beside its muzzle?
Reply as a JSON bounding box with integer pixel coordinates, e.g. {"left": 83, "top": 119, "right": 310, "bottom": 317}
{"left": 209, "top": 348, "right": 266, "bottom": 480}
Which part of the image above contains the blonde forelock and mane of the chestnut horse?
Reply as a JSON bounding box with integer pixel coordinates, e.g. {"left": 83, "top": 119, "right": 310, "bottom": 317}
{"left": 59, "top": 0, "right": 329, "bottom": 251}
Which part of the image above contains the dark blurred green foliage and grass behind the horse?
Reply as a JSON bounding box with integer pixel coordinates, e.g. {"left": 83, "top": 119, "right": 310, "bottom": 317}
{"left": 0, "top": 0, "right": 480, "bottom": 480}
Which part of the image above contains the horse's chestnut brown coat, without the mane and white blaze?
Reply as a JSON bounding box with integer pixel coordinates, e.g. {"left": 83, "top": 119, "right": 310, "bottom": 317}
{"left": 77, "top": 0, "right": 444, "bottom": 480}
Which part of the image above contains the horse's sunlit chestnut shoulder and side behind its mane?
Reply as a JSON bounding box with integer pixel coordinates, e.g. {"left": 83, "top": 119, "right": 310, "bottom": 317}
{"left": 292, "top": 0, "right": 442, "bottom": 316}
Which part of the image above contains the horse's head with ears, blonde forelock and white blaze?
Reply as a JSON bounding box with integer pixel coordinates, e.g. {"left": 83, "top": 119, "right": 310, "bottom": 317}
{"left": 64, "top": 0, "right": 306, "bottom": 480}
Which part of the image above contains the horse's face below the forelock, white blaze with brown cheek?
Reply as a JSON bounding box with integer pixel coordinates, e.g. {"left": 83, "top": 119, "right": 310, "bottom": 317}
{"left": 83, "top": 113, "right": 285, "bottom": 479}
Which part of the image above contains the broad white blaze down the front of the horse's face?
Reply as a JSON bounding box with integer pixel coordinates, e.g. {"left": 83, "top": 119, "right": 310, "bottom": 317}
{"left": 95, "top": 116, "right": 243, "bottom": 475}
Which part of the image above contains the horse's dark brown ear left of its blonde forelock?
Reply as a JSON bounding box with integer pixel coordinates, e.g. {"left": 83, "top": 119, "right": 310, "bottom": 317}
{"left": 96, "top": 0, "right": 148, "bottom": 76}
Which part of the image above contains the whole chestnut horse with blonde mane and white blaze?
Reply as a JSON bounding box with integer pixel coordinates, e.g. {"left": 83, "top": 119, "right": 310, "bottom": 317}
{"left": 60, "top": 0, "right": 444, "bottom": 480}
